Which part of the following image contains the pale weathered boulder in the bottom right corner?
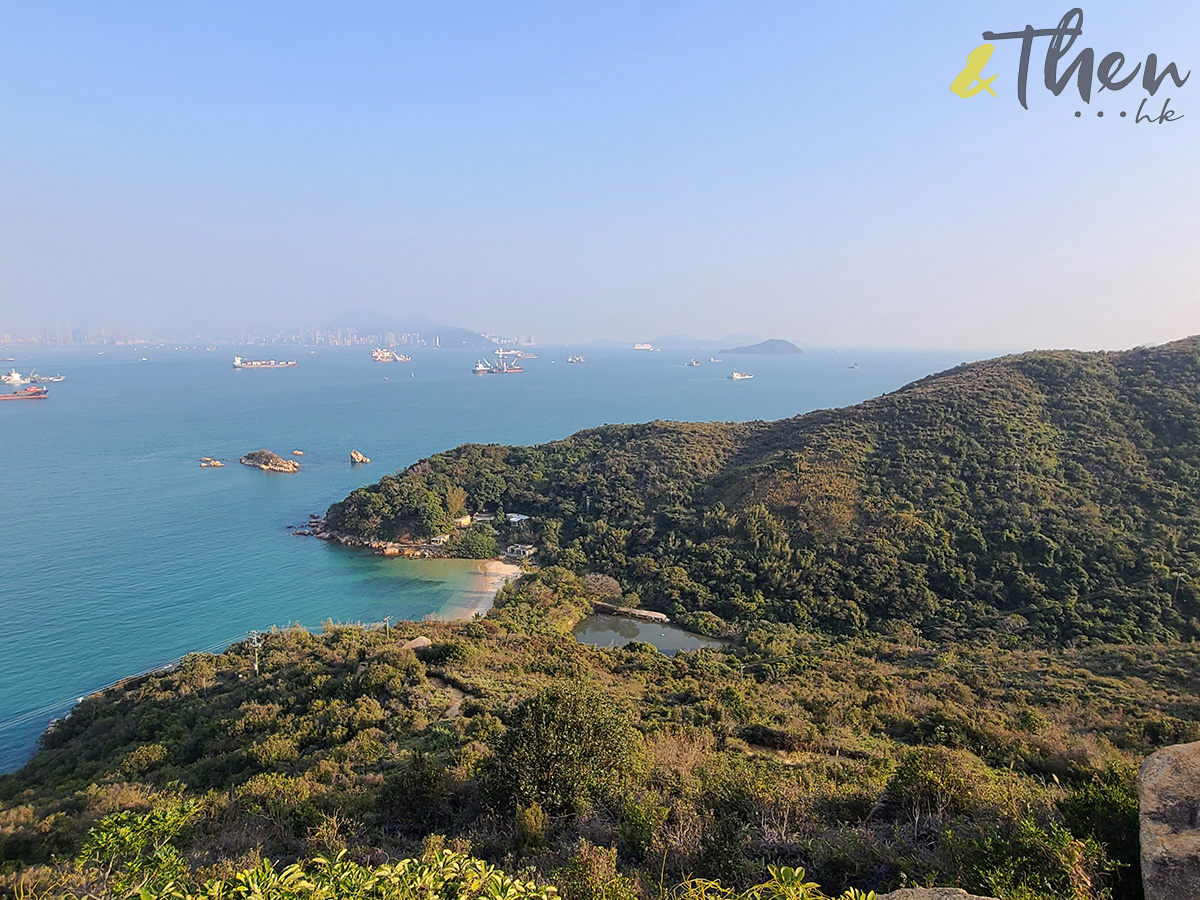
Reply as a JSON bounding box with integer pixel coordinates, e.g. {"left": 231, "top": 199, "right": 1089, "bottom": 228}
{"left": 1138, "top": 742, "right": 1200, "bottom": 900}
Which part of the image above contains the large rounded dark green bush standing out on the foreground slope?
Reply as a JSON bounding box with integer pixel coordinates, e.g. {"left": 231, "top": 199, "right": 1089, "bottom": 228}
{"left": 488, "top": 682, "right": 641, "bottom": 815}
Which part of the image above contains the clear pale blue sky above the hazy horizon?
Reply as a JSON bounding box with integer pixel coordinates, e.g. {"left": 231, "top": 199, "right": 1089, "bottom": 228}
{"left": 0, "top": 0, "right": 1200, "bottom": 349}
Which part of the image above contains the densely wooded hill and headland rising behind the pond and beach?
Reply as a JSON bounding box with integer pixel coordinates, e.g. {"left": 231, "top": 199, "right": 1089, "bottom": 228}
{"left": 326, "top": 338, "right": 1200, "bottom": 647}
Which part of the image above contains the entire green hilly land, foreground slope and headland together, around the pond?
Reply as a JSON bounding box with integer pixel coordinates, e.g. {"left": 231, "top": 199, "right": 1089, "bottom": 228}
{"left": 7, "top": 338, "right": 1200, "bottom": 900}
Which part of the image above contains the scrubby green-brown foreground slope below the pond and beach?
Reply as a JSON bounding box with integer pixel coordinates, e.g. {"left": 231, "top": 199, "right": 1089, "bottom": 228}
{"left": 9, "top": 568, "right": 1200, "bottom": 900}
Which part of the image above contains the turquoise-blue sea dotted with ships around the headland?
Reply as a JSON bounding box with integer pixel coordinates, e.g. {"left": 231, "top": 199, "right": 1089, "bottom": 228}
{"left": 0, "top": 346, "right": 995, "bottom": 772}
